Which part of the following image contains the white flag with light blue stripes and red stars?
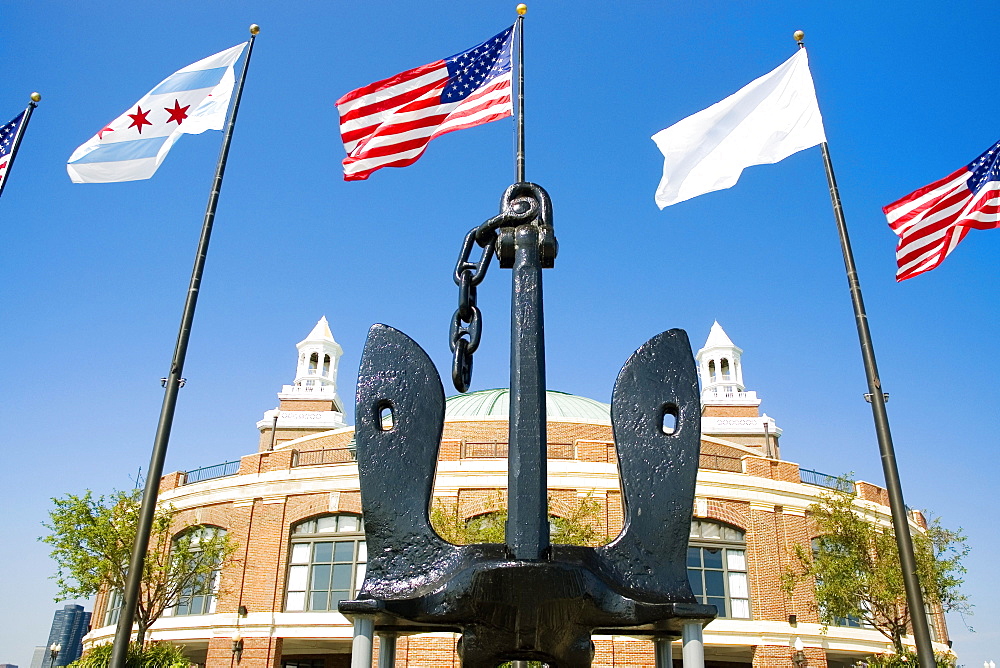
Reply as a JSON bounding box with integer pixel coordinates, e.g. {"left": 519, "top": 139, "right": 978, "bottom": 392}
{"left": 66, "top": 42, "right": 246, "bottom": 183}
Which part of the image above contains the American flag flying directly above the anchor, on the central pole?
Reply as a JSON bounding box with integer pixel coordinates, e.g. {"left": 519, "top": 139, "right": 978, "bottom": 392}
{"left": 337, "top": 26, "right": 514, "bottom": 181}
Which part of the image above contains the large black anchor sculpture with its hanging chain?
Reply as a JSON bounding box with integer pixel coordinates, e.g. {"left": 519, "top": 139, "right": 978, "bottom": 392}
{"left": 340, "top": 183, "right": 716, "bottom": 668}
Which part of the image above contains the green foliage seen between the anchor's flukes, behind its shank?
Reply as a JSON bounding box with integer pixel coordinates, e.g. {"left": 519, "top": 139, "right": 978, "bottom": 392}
{"left": 431, "top": 492, "right": 606, "bottom": 546}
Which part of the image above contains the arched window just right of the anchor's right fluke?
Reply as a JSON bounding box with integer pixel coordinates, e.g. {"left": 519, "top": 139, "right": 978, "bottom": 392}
{"left": 688, "top": 520, "right": 750, "bottom": 619}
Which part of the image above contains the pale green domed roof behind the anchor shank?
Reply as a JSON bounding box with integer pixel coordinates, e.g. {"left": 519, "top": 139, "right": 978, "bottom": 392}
{"left": 444, "top": 388, "right": 611, "bottom": 424}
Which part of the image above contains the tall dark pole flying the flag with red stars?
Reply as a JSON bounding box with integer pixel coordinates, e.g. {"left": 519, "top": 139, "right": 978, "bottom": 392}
{"left": 109, "top": 24, "right": 260, "bottom": 668}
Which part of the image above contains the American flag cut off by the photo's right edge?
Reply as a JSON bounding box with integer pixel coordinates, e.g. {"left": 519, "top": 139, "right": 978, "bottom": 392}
{"left": 882, "top": 142, "right": 1000, "bottom": 281}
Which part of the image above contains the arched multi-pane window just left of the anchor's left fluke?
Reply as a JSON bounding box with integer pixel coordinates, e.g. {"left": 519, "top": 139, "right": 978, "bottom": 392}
{"left": 285, "top": 515, "right": 368, "bottom": 612}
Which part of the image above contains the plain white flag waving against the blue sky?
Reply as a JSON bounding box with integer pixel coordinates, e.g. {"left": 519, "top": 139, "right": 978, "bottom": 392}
{"left": 653, "top": 49, "right": 826, "bottom": 209}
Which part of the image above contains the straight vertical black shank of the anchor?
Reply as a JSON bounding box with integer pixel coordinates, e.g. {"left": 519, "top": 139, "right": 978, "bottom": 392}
{"left": 506, "top": 224, "right": 549, "bottom": 560}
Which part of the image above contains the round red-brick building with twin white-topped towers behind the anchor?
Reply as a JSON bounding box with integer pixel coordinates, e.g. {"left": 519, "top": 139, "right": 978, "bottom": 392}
{"left": 87, "top": 318, "right": 947, "bottom": 668}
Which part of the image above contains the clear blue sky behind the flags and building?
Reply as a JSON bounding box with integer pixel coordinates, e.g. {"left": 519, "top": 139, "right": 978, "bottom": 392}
{"left": 0, "top": 0, "right": 1000, "bottom": 668}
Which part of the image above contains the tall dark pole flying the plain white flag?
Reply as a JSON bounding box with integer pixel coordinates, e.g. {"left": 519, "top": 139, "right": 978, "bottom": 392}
{"left": 794, "top": 30, "right": 936, "bottom": 668}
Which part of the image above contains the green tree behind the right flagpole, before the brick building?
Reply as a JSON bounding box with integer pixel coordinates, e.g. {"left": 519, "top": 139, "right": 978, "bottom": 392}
{"left": 784, "top": 479, "right": 969, "bottom": 655}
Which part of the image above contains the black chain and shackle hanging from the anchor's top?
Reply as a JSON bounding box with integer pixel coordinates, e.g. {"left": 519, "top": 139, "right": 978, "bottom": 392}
{"left": 448, "top": 183, "right": 555, "bottom": 392}
